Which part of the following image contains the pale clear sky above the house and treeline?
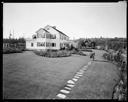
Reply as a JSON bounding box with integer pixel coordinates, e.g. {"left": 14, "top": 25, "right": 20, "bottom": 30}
{"left": 3, "top": 1, "right": 127, "bottom": 39}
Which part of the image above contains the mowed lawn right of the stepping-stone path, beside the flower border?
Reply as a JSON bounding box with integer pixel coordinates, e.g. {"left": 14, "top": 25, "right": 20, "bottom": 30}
{"left": 68, "top": 50, "right": 119, "bottom": 99}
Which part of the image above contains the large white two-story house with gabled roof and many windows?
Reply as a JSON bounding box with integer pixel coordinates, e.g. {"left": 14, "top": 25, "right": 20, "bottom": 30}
{"left": 26, "top": 25, "right": 69, "bottom": 50}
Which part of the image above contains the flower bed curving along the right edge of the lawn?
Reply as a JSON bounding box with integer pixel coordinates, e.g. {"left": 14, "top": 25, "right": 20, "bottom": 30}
{"left": 103, "top": 53, "right": 127, "bottom": 101}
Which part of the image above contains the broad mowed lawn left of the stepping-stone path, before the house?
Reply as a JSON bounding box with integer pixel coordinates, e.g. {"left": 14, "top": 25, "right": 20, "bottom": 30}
{"left": 3, "top": 51, "right": 90, "bottom": 99}
